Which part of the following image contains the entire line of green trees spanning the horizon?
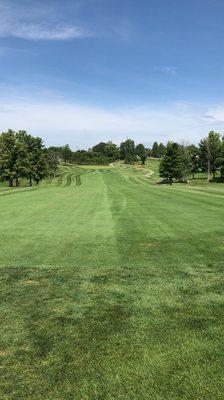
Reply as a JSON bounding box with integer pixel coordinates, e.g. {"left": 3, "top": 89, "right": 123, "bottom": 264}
{"left": 0, "top": 129, "right": 224, "bottom": 187}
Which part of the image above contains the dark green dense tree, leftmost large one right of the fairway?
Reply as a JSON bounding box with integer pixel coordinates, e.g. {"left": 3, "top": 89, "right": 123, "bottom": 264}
{"left": 159, "top": 142, "right": 183, "bottom": 185}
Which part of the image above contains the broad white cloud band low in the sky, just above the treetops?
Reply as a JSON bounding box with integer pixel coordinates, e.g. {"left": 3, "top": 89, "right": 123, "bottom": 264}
{"left": 0, "top": 99, "right": 224, "bottom": 148}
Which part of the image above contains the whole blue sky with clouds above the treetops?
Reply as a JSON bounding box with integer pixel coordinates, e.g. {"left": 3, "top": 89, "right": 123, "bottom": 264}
{"left": 0, "top": 0, "right": 224, "bottom": 148}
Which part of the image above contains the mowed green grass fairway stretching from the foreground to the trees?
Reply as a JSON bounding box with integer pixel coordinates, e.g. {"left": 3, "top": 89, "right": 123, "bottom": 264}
{"left": 0, "top": 167, "right": 224, "bottom": 400}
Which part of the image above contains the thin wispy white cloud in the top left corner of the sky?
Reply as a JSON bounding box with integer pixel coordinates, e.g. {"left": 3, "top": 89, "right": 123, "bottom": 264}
{"left": 0, "top": 2, "right": 93, "bottom": 40}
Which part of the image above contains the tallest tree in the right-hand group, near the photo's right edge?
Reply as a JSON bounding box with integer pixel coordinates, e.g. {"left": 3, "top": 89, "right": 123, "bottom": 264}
{"left": 199, "top": 131, "right": 221, "bottom": 181}
